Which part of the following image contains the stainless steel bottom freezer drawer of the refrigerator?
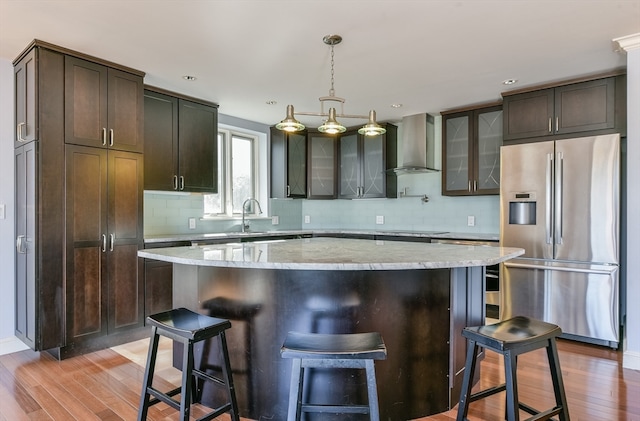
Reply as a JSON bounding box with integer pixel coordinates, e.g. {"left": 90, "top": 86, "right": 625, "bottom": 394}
{"left": 500, "top": 259, "right": 620, "bottom": 347}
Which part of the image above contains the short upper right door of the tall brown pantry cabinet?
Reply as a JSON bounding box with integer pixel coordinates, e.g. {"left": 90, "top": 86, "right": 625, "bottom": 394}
{"left": 107, "top": 69, "right": 144, "bottom": 152}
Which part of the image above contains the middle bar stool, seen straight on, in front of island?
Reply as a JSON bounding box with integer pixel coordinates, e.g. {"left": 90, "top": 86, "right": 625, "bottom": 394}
{"left": 280, "top": 332, "right": 387, "bottom": 421}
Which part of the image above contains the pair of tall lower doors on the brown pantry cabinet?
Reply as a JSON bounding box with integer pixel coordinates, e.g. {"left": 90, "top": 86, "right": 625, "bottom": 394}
{"left": 65, "top": 145, "right": 144, "bottom": 347}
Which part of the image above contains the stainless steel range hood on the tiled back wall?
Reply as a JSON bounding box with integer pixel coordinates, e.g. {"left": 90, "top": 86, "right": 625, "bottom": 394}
{"left": 392, "top": 113, "right": 440, "bottom": 174}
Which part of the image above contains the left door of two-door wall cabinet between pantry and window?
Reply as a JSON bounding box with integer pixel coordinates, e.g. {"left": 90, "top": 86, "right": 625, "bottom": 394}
{"left": 144, "top": 91, "right": 178, "bottom": 191}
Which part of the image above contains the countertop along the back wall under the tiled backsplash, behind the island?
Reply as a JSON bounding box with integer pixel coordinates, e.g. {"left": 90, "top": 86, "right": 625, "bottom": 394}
{"left": 144, "top": 229, "right": 500, "bottom": 244}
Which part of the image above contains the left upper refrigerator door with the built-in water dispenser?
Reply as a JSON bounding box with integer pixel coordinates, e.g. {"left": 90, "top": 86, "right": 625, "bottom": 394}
{"left": 500, "top": 141, "right": 554, "bottom": 259}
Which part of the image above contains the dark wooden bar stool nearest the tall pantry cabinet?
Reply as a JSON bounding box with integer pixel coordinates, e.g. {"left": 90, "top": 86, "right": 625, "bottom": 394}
{"left": 138, "top": 308, "right": 240, "bottom": 421}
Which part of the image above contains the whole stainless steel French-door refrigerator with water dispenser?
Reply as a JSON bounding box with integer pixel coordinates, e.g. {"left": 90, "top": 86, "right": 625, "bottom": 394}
{"left": 500, "top": 134, "right": 620, "bottom": 348}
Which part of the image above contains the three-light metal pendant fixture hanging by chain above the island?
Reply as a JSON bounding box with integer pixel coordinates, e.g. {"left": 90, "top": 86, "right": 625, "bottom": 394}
{"left": 276, "top": 35, "right": 387, "bottom": 136}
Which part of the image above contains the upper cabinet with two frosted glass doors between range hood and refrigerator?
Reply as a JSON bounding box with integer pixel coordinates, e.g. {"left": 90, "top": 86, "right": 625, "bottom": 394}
{"left": 442, "top": 105, "right": 503, "bottom": 196}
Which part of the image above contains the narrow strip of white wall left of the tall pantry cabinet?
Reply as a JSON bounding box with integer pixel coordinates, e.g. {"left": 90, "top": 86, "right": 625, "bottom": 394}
{"left": 0, "top": 59, "right": 15, "bottom": 340}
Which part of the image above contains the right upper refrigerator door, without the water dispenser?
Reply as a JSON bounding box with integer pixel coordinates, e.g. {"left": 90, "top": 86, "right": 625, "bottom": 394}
{"left": 554, "top": 134, "right": 620, "bottom": 263}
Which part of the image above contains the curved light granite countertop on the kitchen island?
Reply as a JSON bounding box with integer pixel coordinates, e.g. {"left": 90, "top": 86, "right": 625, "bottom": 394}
{"left": 138, "top": 237, "right": 524, "bottom": 270}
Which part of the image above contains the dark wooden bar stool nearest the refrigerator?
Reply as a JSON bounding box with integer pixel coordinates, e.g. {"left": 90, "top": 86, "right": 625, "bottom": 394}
{"left": 457, "top": 316, "right": 569, "bottom": 421}
